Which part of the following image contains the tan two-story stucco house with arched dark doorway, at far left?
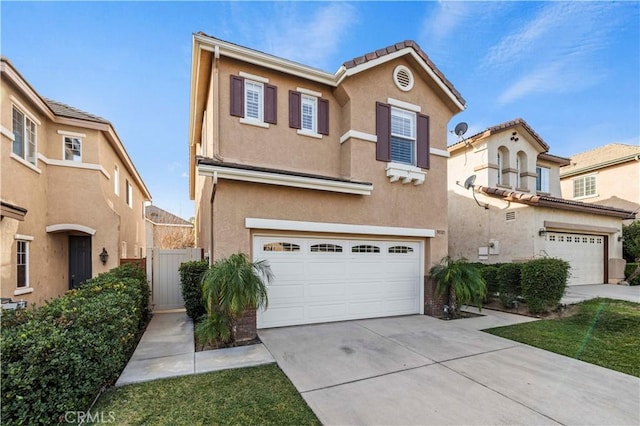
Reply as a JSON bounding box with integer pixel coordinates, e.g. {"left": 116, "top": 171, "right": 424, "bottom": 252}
{"left": 0, "top": 58, "right": 151, "bottom": 303}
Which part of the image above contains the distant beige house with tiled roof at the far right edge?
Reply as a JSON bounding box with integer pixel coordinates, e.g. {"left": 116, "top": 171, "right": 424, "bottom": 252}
{"left": 560, "top": 143, "right": 640, "bottom": 223}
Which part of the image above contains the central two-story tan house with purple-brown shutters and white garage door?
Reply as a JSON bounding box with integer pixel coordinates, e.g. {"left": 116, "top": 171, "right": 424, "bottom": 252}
{"left": 189, "top": 33, "right": 465, "bottom": 335}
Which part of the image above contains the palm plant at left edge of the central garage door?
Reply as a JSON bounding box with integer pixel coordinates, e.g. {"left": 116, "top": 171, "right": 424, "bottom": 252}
{"left": 196, "top": 253, "right": 273, "bottom": 343}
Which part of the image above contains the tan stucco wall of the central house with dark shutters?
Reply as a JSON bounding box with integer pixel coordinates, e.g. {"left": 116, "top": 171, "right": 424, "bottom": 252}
{"left": 195, "top": 51, "right": 453, "bottom": 268}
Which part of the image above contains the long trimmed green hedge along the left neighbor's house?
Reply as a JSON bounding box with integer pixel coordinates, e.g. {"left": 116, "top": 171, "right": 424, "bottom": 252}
{"left": 0, "top": 265, "right": 149, "bottom": 424}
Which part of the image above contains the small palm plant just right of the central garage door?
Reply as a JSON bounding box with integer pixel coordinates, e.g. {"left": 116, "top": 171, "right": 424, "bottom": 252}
{"left": 429, "top": 256, "right": 487, "bottom": 316}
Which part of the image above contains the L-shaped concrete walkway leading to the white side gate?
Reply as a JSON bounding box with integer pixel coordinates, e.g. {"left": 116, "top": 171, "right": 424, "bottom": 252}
{"left": 116, "top": 312, "right": 275, "bottom": 386}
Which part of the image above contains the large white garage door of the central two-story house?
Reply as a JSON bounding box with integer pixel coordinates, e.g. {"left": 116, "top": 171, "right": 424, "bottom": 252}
{"left": 253, "top": 237, "right": 422, "bottom": 328}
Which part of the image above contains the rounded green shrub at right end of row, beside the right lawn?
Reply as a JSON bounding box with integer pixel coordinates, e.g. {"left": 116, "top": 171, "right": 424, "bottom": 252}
{"left": 522, "top": 258, "right": 569, "bottom": 314}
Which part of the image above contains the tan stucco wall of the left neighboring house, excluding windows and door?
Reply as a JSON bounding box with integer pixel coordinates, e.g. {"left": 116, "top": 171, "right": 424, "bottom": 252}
{"left": 0, "top": 68, "right": 145, "bottom": 304}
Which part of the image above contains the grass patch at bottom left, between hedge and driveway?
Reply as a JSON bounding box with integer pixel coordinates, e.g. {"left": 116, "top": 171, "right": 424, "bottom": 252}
{"left": 87, "top": 364, "right": 320, "bottom": 425}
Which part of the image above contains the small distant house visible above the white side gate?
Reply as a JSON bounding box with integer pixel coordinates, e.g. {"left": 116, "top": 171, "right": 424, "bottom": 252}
{"left": 145, "top": 205, "right": 194, "bottom": 250}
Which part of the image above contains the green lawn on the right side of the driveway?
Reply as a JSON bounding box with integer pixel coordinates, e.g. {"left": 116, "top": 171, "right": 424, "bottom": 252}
{"left": 484, "top": 299, "right": 640, "bottom": 377}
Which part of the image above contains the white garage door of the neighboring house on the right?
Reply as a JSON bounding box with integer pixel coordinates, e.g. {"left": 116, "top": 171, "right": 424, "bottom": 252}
{"left": 545, "top": 232, "right": 605, "bottom": 285}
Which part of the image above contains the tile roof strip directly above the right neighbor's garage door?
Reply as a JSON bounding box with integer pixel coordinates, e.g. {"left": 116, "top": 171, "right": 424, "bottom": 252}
{"left": 478, "top": 186, "right": 634, "bottom": 219}
